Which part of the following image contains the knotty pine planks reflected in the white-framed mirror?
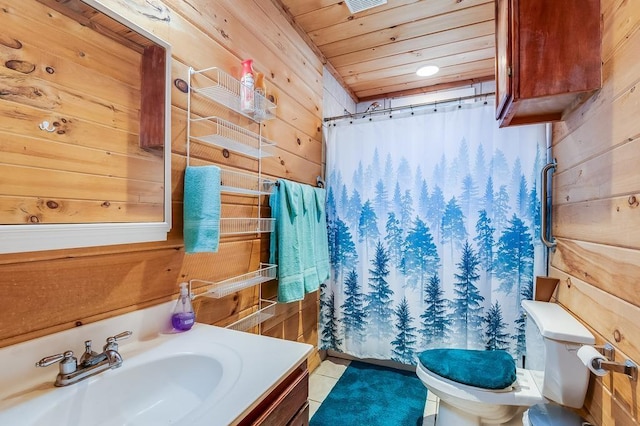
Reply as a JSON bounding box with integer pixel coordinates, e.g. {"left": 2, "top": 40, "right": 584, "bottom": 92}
{"left": 0, "top": 2, "right": 164, "bottom": 224}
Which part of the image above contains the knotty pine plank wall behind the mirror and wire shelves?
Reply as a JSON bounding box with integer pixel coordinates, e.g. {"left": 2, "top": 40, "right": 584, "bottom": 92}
{"left": 0, "top": 0, "right": 324, "bottom": 368}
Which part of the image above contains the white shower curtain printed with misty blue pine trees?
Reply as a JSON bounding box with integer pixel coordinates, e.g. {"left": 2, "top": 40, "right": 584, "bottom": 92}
{"left": 319, "top": 102, "right": 545, "bottom": 364}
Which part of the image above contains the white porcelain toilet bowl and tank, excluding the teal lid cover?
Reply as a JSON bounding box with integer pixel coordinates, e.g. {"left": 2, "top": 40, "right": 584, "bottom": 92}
{"left": 416, "top": 300, "right": 595, "bottom": 426}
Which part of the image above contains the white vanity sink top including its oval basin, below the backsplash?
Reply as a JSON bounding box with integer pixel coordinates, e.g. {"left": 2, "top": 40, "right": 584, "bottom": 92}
{"left": 0, "top": 302, "right": 311, "bottom": 426}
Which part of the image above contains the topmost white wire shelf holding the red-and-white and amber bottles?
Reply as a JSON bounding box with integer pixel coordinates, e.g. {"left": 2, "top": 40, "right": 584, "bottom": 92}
{"left": 191, "top": 67, "right": 276, "bottom": 122}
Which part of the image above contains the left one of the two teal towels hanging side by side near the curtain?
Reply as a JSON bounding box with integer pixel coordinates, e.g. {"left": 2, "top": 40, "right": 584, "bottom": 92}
{"left": 271, "top": 179, "right": 304, "bottom": 303}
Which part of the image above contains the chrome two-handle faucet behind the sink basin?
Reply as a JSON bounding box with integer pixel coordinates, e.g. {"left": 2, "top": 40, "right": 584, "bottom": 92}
{"left": 36, "top": 331, "right": 133, "bottom": 386}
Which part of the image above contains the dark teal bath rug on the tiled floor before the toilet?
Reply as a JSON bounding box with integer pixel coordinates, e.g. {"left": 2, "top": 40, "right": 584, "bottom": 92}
{"left": 309, "top": 361, "right": 427, "bottom": 426}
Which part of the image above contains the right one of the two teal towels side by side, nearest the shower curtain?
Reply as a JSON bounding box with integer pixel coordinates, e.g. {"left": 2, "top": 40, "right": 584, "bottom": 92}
{"left": 298, "top": 185, "right": 320, "bottom": 293}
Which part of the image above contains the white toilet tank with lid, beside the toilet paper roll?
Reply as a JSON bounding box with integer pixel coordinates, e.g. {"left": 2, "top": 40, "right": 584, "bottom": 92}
{"left": 522, "top": 300, "right": 595, "bottom": 408}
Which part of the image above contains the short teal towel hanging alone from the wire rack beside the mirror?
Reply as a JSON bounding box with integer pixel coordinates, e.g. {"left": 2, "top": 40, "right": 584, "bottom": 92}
{"left": 183, "top": 166, "right": 220, "bottom": 253}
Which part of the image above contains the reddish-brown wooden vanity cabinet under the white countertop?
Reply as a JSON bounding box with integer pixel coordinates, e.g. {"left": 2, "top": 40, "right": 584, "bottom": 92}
{"left": 239, "top": 361, "right": 309, "bottom": 426}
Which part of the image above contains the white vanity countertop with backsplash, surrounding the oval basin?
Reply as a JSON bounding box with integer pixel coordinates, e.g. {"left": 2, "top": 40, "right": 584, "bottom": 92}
{"left": 0, "top": 303, "right": 313, "bottom": 426}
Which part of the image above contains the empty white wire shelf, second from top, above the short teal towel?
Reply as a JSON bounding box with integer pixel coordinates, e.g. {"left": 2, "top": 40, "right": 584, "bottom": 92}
{"left": 191, "top": 117, "right": 275, "bottom": 158}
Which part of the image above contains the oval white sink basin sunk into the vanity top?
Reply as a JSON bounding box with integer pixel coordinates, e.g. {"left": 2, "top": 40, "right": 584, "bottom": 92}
{"left": 34, "top": 354, "right": 228, "bottom": 426}
